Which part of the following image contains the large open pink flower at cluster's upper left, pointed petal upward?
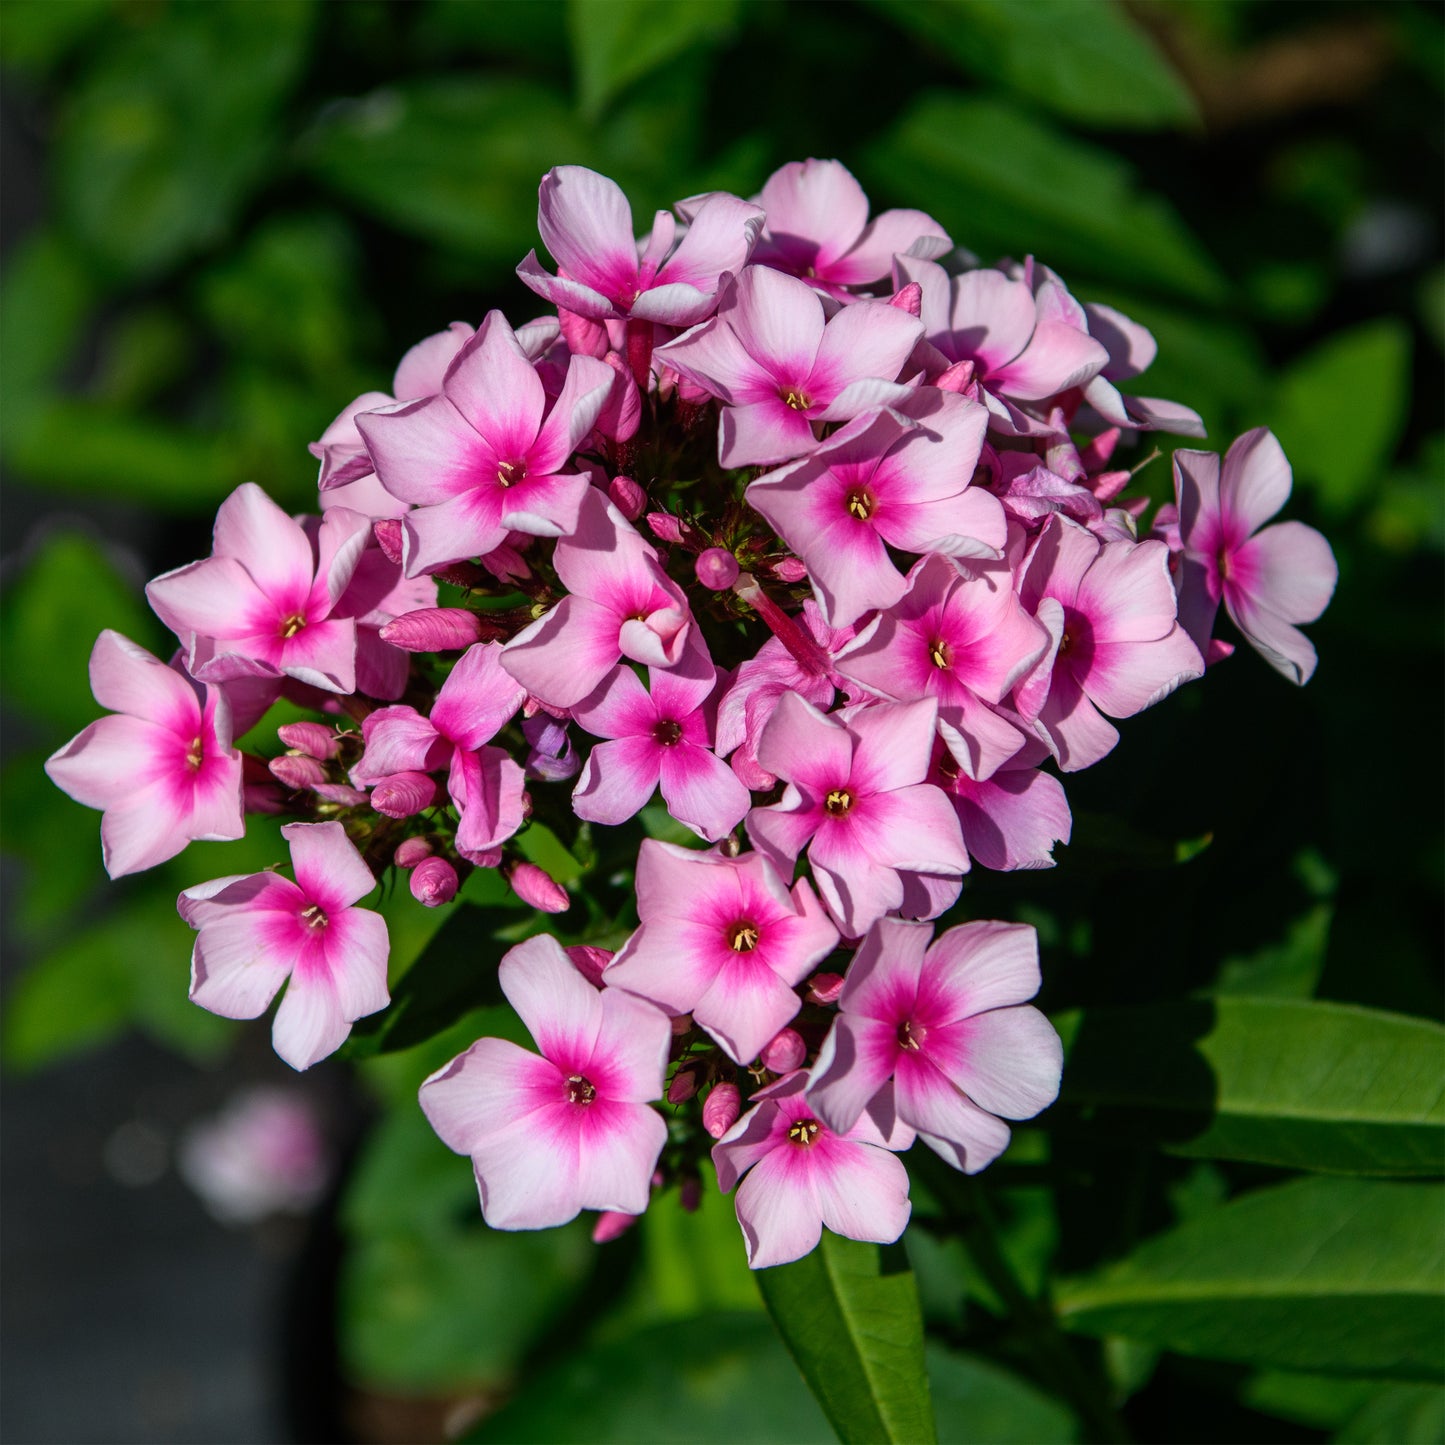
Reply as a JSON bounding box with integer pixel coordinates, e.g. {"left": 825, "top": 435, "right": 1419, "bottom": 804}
{"left": 357, "top": 311, "right": 616, "bottom": 577}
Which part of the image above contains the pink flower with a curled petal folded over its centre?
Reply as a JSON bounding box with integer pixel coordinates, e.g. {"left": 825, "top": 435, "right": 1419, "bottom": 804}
{"left": 503, "top": 488, "right": 696, "bottom": 708}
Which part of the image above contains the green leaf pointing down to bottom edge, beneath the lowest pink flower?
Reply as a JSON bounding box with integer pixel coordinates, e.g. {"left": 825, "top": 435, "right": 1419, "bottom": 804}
{"left": 757, "top": 1230, "right": 936, "bottom": 1445}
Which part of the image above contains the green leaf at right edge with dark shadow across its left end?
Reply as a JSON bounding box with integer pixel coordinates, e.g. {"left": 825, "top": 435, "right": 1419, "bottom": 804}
{"left": 1051, "top": 996, "right": 1445, "bottom": 1176}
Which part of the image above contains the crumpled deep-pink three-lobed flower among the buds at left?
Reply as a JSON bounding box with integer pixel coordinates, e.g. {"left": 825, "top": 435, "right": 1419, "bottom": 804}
{"left": 351, "top": 642, "right": 525, "bottom": 853}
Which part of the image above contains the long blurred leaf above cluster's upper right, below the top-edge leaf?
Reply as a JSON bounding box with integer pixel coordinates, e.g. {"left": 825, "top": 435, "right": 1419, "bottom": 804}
{"left": 864, "top": 91, "right": 1227, "bottom": 302}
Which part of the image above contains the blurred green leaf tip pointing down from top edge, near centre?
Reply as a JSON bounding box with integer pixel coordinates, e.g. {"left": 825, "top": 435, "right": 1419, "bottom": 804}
{"left": 566, "top": 0, "right": 737, "bottom": 120}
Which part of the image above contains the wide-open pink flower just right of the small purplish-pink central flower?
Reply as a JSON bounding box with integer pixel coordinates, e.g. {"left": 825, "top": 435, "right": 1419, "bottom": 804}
{"left": 747, "top": 694, "right": 968, "bottom": 938}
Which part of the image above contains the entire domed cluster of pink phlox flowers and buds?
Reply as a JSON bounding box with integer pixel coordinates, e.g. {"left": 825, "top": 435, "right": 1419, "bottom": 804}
{"left": 48, "top": 160, "right": 1335, "bottom": 1267}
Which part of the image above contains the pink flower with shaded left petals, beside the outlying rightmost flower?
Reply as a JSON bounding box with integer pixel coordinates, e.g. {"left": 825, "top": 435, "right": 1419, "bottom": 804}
{"left": 1014, "top": 513, "right": 1204, "bottom": 773}
